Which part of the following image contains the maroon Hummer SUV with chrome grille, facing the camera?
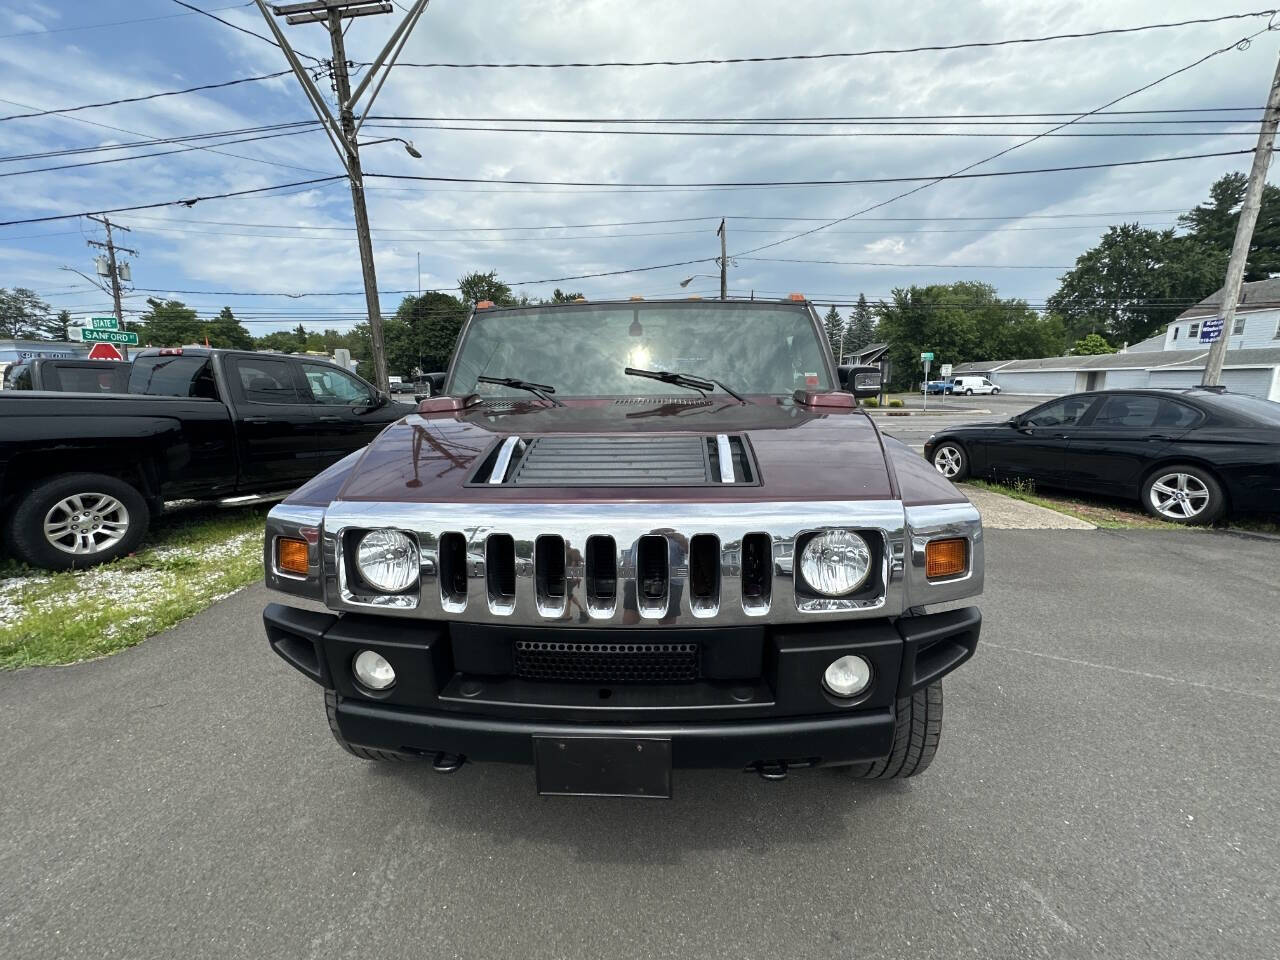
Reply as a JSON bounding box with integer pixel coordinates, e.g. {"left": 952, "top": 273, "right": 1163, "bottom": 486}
{"left": 257, "top": 298, "right": 983, "bottom": 796}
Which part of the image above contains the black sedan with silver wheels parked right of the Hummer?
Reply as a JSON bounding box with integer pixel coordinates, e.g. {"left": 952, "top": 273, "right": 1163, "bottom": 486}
{"left": 924, "top": 387, "right": 1280, "bottom": 524}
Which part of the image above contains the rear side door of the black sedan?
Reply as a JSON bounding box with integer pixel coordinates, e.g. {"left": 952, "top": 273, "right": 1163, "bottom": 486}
{"left": 1065, "top": 393, "right": 1203, "bottom": 497}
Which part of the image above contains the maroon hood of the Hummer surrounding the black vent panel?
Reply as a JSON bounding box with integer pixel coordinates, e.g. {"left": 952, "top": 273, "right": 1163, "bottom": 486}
{"left": 330, "top": 397, "right": 895, "bottom": 503}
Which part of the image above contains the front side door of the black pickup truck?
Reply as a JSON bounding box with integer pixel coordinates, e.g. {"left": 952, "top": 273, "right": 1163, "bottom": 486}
{"left": 297, "top": 360, "right": 401, "bottom": 470}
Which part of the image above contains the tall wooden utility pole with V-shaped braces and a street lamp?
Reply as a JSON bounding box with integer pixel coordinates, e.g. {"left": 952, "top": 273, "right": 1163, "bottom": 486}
{"left": 255, "top": 0, "right": 428, "bottom": 390}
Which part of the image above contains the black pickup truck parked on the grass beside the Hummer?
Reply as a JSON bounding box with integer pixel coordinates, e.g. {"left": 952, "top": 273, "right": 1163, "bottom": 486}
{"left": 0, "top": 347, "right": 412, "bottom": 570}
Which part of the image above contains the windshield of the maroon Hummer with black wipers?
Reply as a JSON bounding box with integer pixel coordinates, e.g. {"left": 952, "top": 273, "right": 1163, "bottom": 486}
{"left": 449, "top": 302, "right": 831, "bottom": 397}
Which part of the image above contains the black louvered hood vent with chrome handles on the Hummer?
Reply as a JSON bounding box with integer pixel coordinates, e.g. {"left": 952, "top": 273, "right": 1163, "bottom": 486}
{"left": 470, "top": 434, "right": 759, "bottom": 486}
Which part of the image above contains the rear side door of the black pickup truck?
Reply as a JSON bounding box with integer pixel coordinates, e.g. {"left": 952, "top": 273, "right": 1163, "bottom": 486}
{"left": 225, "top": 355, "right": 319, "bottom": 492}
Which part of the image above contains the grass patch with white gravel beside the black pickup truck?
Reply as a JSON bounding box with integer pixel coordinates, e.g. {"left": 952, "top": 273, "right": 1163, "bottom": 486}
{"left": 0, "top": 504, "right": 268, "bottom": 669}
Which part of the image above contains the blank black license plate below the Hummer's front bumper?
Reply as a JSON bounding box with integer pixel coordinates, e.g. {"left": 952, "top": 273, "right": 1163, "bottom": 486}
{"left": 534, "top": 736, "right": 671, "bottom": 797}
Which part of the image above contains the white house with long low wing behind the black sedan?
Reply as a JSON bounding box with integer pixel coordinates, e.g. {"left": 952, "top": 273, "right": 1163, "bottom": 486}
{"left": 952, "top": 279, "right": 1280, "bottom": 401}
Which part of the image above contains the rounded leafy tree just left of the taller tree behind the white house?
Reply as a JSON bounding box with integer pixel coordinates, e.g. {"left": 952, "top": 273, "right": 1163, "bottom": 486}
{"left": 1048, "top": 224, "right": 1228, "bottom": 343}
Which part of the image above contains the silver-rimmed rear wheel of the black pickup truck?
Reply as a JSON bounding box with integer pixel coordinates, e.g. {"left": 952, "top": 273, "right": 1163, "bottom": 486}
{"left": 10, "top": 474, "right": 151, "bottom": 570}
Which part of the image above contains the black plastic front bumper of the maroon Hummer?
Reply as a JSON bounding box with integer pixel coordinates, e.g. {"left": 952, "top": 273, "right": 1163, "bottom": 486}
{"left": 264, "top": 603, "right": 982, "bottom": 769}
